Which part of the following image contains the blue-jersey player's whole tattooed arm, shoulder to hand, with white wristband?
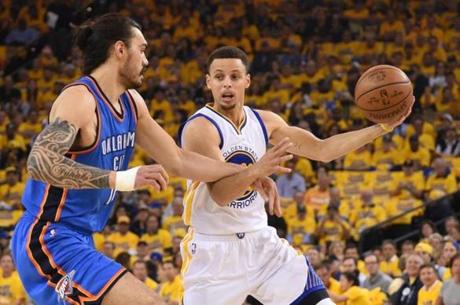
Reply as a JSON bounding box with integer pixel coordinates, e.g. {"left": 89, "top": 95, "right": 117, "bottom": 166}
{"left": 27, "top": 86, "right": 168, "bottom": 191}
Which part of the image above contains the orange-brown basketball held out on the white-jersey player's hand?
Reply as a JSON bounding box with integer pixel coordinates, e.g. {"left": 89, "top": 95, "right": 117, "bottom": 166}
{"left": 355, "top": 65, "right": 413, "bottom": 123}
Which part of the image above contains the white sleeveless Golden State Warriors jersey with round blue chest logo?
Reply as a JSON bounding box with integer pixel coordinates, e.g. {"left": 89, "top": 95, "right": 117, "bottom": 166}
{"left": 179, "top": 106, "right": 268, "bottom": 234}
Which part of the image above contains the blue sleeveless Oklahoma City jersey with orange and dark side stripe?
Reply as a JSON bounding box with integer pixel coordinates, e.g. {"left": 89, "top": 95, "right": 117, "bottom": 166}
{"left": 22, "top": 76, "right": 137, "bottom": 234}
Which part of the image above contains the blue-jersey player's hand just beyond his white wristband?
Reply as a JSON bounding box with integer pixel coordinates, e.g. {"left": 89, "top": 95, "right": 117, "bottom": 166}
{"left": 134, "top": 164, "right": 169, "bottom": 191}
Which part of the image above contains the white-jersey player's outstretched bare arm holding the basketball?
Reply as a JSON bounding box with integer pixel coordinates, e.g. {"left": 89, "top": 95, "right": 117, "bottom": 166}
{"left": 260, "top": 98, "right": 413, "bottom": 162}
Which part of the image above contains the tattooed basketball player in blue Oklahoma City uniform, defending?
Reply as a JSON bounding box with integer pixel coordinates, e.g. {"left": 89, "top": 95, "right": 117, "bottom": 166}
{"left": 11, "top": 14, "right": 290, "bottom": 305}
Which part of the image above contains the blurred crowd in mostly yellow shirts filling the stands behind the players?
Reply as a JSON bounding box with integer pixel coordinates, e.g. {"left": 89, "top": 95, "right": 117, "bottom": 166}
{"left": 0, "top": 0, "right": 460, "bottom": 305}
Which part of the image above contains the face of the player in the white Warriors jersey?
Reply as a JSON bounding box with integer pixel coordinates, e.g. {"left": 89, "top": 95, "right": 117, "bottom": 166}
{"left": 206, "top": 58, "right": 250, "bottom": 110}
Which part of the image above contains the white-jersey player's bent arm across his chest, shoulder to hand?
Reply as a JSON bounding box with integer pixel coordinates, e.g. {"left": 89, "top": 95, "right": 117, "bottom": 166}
{"left": 183, "top": 117, "right": 292, "bottom": 206}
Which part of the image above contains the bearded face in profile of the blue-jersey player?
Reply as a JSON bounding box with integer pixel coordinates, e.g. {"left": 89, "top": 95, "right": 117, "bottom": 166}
{"left": 120, "top": 28, "right": 149, "bottom": 89}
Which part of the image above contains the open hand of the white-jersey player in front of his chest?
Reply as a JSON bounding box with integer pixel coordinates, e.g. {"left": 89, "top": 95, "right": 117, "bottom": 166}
{"left": 253, "top": 138, "right": 293, "bottom": 177}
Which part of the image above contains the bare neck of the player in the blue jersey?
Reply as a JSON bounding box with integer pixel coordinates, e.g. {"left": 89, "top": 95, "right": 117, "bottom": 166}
{"left": 91, "top": 65, "right": 126, "bottom": 105}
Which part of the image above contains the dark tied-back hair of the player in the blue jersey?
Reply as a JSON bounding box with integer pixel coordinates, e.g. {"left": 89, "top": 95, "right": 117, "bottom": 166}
{"left": 74, "top": 13, "right": 141, "bottom": 74}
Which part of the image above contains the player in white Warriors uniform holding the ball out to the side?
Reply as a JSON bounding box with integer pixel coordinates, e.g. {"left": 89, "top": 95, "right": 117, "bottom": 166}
{"left": 180, "top": 47, "right": 410, "bottom": 305}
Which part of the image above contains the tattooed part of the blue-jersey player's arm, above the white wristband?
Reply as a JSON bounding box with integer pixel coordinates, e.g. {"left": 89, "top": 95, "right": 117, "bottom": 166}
{"left": 27, "top": 118, "right": 110, "bottom": 189}
